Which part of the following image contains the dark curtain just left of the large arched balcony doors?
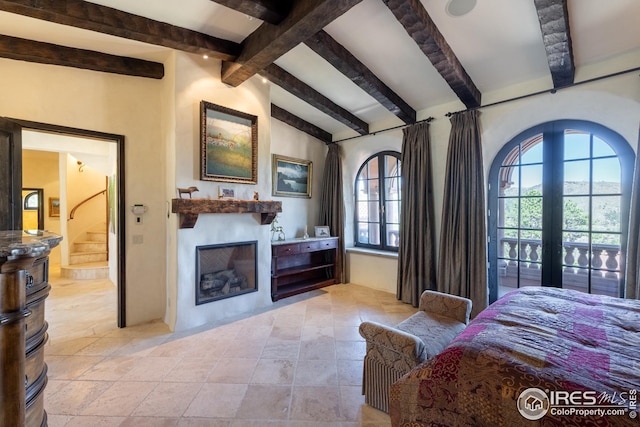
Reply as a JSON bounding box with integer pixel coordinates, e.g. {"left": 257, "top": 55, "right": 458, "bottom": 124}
{"left": 438, "top": 110, "right": 487, "bottom": 316}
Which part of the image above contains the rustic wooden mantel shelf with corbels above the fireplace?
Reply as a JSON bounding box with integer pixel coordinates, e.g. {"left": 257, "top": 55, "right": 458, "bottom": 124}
{"left": 171, "top": 199, "right": 282, "bottom": 228}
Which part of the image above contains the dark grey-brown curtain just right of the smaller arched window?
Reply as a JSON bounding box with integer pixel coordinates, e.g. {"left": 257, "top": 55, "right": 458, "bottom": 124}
{"left": 396, "top": 122, "right": 436, "bottom": 307}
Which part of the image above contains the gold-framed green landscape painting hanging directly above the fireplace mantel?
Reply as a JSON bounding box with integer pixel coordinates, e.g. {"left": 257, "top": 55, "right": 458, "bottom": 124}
{"left": 200, "top": 101, "right": 258, "bottom": 184}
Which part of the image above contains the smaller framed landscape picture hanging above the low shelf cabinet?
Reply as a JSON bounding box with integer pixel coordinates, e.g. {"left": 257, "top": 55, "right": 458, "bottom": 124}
{"left": 271, "top": 154, "right": 313, "bottom": 199}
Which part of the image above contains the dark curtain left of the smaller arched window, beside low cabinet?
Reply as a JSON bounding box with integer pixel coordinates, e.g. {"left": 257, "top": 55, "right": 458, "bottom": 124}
{"left": 318, "top": 144, "right": 345, "bottom": 283}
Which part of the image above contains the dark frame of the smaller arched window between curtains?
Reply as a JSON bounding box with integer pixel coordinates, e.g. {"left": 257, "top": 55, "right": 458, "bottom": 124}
{"left": 354, "top": 150, "right": 402, "bottom": 252}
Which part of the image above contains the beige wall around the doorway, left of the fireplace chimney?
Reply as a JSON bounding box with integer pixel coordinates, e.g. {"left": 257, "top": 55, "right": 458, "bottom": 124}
{"left": 0, "top": 59, "right": 167, "bottom": 325}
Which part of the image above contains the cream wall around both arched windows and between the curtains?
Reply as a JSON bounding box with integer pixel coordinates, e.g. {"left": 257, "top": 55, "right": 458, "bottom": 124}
{"left": 348, "top": 73, "right": 640, "bottom": 292}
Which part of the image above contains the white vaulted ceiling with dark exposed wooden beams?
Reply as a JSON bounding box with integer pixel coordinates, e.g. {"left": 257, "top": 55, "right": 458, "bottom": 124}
{"left": 0, "top": 0, "right": 640, "bottom": 143}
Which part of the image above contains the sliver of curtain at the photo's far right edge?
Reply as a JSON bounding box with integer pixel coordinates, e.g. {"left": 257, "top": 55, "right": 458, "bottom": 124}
{"left": 625, "top": 126, "right": 640, "bottom": 299}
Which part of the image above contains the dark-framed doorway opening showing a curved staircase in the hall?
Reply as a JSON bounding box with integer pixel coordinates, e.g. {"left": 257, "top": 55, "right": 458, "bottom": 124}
{"left": 17, "top": 121, "right": 126, "bottom": 332}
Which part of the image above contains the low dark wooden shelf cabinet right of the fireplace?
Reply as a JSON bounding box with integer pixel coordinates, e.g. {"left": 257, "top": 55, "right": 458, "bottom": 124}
{"left": 271, "top": 237, "right": 338, "bottom": 301}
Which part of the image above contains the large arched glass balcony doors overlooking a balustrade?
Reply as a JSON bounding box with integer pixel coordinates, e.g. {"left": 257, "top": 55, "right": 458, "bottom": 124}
{"left": 489, "top": 120, "right": 635, "bottom": 302}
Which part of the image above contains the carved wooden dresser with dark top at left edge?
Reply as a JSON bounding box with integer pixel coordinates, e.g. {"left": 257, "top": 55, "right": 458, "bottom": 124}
{"left": 0, "top": 231, "right": 62, "bottom": 427}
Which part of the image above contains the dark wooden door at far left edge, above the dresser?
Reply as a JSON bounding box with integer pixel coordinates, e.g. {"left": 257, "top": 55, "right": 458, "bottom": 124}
{"left": 0, "top": 117, "right": 22, "bottom": 230}
